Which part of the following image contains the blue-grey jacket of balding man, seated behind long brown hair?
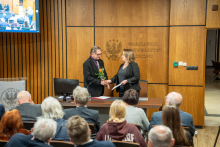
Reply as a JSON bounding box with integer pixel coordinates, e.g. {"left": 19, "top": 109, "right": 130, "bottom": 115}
{"left": 149, "top": 109, "right": 195, "bottom": 136}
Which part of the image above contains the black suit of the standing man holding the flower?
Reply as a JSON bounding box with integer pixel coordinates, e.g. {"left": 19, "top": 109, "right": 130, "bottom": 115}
{"left": 83, "top": 57, "right": 108, "bottom": 97}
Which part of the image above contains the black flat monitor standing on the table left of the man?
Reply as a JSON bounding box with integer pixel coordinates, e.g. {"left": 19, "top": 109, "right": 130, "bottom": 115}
{"left": 54, "top": 78, "right": 79, "bottom": 96}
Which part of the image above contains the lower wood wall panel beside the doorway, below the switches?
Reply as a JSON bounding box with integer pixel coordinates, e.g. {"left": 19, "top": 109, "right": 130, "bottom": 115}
{"left": 169, "top": 86, "right": 204, "bottom": 126}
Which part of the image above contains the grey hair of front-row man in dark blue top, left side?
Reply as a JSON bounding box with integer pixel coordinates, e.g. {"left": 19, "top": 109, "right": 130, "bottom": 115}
{"left": 31, "top": 117, "right": 57, "bottom": 142}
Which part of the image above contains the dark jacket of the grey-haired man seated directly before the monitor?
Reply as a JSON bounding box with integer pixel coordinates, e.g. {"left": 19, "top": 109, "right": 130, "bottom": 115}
{"left": 63, "top": 107, "right": 100, "bottom": 132}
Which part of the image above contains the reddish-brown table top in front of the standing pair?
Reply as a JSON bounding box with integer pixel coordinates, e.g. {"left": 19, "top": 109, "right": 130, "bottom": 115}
{"left": 59, "top": 97, "right": 163, "bottom": 109}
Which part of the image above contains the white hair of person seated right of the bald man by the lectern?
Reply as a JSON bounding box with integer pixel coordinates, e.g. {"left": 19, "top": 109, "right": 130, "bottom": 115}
{"left": 41, "top": 97, "right": 64, "bottom": 119}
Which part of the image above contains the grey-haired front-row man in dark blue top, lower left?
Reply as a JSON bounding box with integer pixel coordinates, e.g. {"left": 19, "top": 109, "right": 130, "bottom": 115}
{"left": 5, "top": 118, "right": 57, "bottom": 147}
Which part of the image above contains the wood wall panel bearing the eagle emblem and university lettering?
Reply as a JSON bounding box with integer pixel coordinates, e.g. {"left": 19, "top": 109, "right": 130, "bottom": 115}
{"left": 95, "top": 27, "right": 169, "bottom": 83}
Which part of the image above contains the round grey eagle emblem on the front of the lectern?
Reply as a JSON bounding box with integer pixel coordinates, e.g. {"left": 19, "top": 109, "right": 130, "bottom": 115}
{"left": 0, "top": 88, "right": 19, "bottom": 108}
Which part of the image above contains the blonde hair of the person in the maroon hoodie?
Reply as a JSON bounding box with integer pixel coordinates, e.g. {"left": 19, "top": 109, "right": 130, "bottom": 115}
{"left": 109, "top": 100, "right": 126, "bottom": 122}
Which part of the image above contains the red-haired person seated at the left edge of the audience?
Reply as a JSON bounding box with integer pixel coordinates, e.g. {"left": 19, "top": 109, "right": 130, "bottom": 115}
{"left": 0, "top": 109, "right": 30, "bottom": 140}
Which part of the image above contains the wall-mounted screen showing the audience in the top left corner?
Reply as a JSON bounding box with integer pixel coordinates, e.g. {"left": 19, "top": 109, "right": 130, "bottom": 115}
{"left": 0, "top": 0, "right": 40, "bottom": 33}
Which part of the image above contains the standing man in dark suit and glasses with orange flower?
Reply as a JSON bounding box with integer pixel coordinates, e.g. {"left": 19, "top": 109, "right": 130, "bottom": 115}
{"left": 83, "top": 46, "right": 108, "bottom": 96}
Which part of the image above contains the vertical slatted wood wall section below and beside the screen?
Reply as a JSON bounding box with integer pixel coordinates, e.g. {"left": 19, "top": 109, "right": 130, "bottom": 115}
{"left": 0, "top": 0, "right": 66, "bottom": 103}
